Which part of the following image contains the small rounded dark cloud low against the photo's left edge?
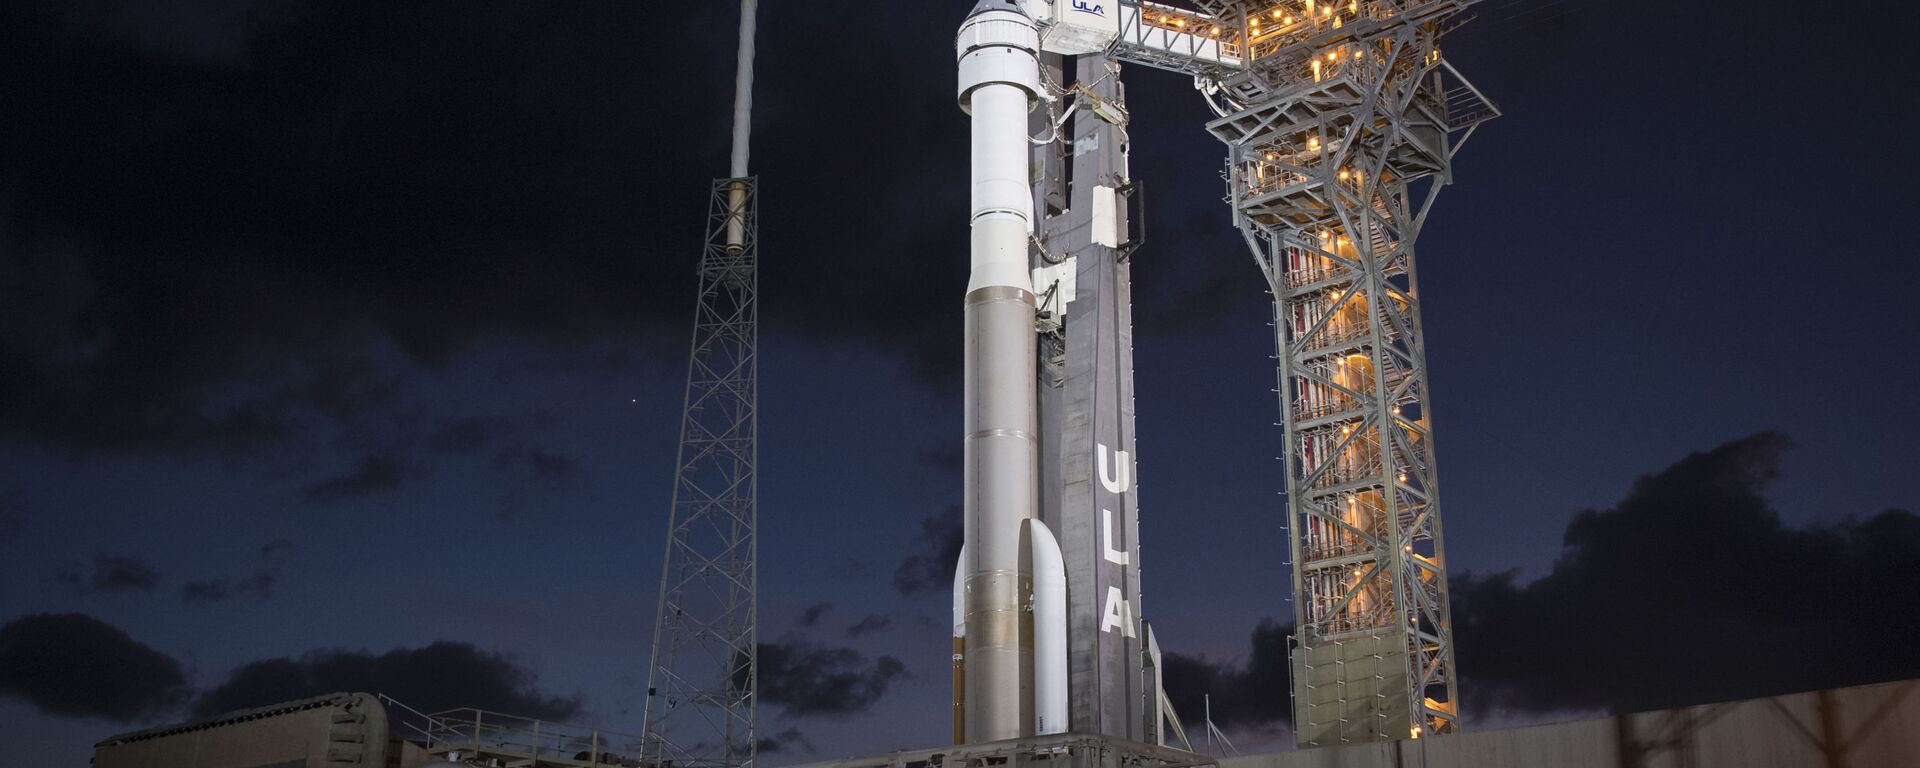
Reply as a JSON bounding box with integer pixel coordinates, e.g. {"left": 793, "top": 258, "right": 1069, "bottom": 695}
{"left": 0, "top": 612, "right": 188, "bottom": 722}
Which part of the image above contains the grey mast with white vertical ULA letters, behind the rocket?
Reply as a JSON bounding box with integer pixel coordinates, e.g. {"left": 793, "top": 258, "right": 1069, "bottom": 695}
{"left": 1033, "top": 54, "right": 1164, "bottom": 743}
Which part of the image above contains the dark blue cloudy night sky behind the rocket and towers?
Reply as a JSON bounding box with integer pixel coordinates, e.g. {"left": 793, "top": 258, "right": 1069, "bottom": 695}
{"left": 0, "top": 0, "right": 1920, "bottom": 766}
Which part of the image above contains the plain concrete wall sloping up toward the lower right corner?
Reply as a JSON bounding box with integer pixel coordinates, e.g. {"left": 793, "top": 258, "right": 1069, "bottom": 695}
{"left": 1219, "top": 680, "right": 1920, "bottom": 768}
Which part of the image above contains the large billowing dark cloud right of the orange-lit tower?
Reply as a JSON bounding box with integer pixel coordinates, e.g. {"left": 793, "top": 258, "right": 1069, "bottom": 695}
{"left": 1453, "top": 432, "right": 1920, "bottom": 712}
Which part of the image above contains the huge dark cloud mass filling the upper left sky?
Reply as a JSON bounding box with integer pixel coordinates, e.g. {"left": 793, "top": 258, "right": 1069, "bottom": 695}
{"left": 0, "top": 0, "right": 990, "bottom": 451}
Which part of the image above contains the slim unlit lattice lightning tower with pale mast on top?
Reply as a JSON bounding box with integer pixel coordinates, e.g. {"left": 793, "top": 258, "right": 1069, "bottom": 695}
{"left": 643, "top": 0, "right": 758, "bottom": 768}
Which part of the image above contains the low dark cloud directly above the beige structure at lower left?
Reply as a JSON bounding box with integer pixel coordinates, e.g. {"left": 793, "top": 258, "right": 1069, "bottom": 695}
{"left": 194, "top": 641, "right": 582, "bottom": 720}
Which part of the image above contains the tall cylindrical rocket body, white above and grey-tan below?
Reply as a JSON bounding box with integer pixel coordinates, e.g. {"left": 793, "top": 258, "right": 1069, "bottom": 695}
{"left": 954, "top": 0, "right": 1041, "bottom": 743}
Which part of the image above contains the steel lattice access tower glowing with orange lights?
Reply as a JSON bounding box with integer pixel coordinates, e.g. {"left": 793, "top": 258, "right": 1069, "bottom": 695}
{"left": 1208, "top": 2, "right": 1498, "bottom": 747}
